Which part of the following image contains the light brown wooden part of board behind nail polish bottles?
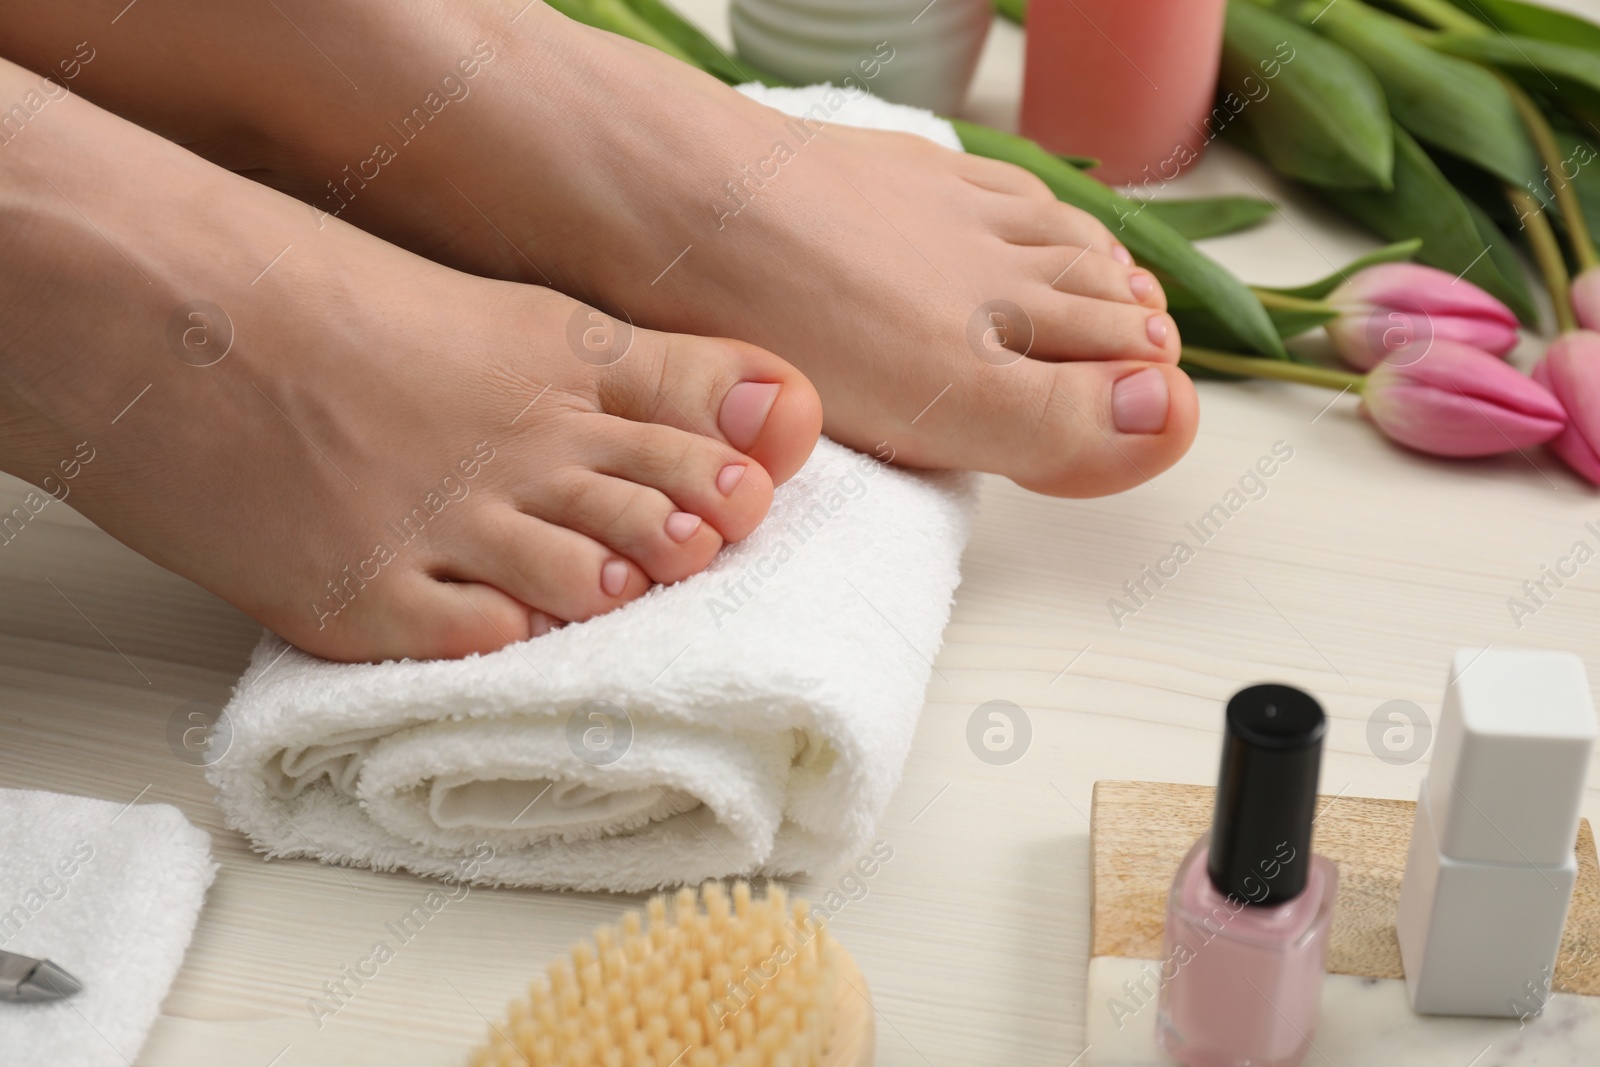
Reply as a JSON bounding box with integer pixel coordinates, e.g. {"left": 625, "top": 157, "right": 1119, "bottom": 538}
{"left": 1090, "top": 782, "right": 1600, "bottom": 995}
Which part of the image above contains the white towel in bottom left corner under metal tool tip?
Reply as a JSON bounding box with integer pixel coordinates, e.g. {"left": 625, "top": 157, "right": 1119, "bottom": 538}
{"left": 0, "top": 789, "right": 216, "bottom": 1067}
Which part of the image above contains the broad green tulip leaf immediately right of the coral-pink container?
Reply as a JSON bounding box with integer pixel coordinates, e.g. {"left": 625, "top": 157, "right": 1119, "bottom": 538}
{"left": 1219, "top": 0, "right": 1394, "bottom": 189}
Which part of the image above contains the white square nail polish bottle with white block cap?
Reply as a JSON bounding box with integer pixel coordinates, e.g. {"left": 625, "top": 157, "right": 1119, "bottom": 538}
{"left": 1395, "top": 648, "right": 1595, "bottom": 1017}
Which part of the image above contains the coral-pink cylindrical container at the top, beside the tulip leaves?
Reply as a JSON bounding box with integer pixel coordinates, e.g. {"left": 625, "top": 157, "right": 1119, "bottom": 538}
{"left": 1022, "top": 0, "right": 1227, "bottom": 184}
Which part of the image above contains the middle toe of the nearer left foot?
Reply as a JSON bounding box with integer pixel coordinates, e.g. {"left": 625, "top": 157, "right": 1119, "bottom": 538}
{"left": 525, "top": 470, "right": 722, "bottom": 585}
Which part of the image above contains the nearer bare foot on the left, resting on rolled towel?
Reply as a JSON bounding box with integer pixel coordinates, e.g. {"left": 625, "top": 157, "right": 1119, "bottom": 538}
{"left": 0, "top": 62, "right": 821, "bottom": 659}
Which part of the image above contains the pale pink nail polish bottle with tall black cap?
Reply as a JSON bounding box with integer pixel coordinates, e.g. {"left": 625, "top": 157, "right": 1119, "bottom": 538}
{"left": 1157, "top": 685, "right": 1339, "bottom": 1067}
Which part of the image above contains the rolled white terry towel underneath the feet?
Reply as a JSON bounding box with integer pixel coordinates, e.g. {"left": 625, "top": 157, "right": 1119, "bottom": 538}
{"left": 208, "top": 440, "right": 974, "bottom": 891}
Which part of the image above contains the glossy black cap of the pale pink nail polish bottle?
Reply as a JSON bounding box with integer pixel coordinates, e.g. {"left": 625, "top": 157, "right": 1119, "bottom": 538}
{"left": 1206, "top": 685, "right": 1328, "bottom": 905}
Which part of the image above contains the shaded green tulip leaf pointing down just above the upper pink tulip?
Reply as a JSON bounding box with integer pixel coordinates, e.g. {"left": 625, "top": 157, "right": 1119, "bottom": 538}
{"left": 1322, "top": 128, "right": 1536, "bottom": 325}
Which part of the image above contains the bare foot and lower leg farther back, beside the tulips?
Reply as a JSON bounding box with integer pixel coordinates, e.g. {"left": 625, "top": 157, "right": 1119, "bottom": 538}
{"left": 0, "top": 0, "right": 1197, "bottom": 496}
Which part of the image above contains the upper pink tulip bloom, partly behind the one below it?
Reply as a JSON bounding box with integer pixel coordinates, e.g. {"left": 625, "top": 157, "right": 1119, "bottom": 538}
{"left": 1326, "top": 262, "right": 1517, "bottom": 371}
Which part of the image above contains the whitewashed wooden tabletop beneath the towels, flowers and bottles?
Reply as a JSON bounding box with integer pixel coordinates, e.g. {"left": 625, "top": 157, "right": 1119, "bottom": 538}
{"left": 0, "top": 8, "right": 1600, "bottom": 1067}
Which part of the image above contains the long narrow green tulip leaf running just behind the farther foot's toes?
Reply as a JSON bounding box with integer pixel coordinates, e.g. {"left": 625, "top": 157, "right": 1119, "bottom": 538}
{"left": 950, "top": 118, "right": 1286, "bottom": 358}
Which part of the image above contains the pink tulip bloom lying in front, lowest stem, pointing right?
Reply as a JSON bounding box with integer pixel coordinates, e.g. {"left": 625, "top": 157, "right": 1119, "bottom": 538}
{"left": 1362, "top": 339, "right": 1566, "bottom": 456}
